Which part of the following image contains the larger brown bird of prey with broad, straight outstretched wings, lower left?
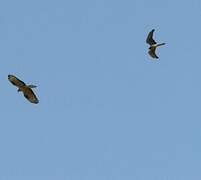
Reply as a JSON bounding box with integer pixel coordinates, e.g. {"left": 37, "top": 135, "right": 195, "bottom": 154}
{"left": 8, "top": 75, "right": 39, "bottom": 104}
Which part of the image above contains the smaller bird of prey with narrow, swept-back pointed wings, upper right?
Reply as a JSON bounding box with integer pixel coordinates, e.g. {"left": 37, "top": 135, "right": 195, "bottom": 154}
{"left": 146, "top": 29, "right": 165, "bottom": 59}
